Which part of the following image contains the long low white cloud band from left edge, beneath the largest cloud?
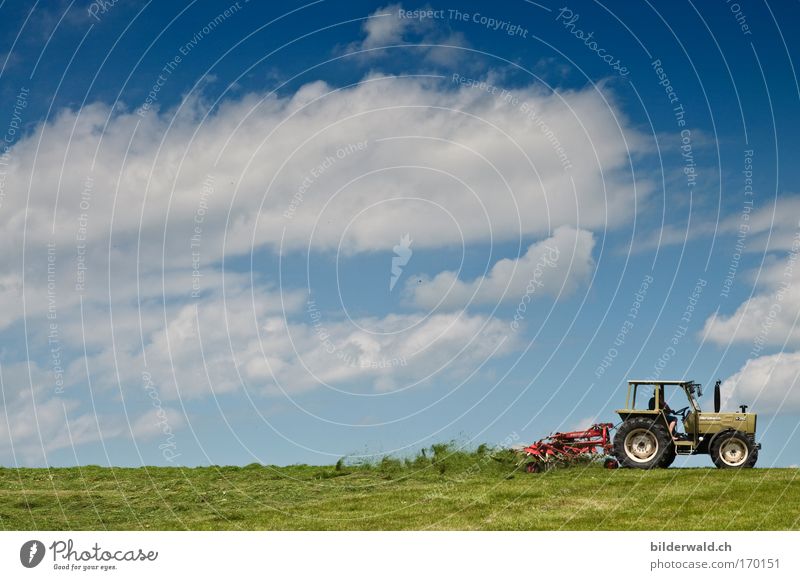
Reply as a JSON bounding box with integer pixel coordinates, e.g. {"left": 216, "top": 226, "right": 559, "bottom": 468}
{"left": 0, "top": 260, "right": 520, "bottom": 464}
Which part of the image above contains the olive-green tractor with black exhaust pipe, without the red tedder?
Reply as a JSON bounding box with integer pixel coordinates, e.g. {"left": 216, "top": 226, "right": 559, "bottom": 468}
{"left": 613, "top": 380, "right": 761, "bottom": 469}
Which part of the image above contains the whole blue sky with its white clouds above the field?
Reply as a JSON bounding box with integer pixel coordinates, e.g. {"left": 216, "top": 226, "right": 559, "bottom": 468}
{"left": 0, "top": 0, "right": 800, "bottom": 466}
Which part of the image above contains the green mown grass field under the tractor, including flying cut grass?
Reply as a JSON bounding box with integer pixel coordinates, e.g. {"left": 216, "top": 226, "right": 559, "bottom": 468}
{"left": 0, "top": 446, "right": 800, "bottom": 530}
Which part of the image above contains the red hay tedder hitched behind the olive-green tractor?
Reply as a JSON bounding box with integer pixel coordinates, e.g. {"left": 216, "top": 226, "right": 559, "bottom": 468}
{"left": 521, "top": 423, "right": 619, "bottom": 473}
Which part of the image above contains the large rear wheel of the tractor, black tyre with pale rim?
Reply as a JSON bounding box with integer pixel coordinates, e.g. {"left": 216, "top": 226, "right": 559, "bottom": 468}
{"left": 614, "top": 417, "right": 675, "bottom": 469}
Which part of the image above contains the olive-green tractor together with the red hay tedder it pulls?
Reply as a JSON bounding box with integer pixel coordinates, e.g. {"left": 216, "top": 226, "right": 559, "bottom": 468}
{"left": 519, "top": 379, "right": 761, "bottom": 473}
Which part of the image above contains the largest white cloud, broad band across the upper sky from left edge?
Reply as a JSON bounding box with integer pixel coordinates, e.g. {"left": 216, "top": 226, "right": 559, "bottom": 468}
{"left": 0, "top": 76, "right": 650, "bottom": 336}
